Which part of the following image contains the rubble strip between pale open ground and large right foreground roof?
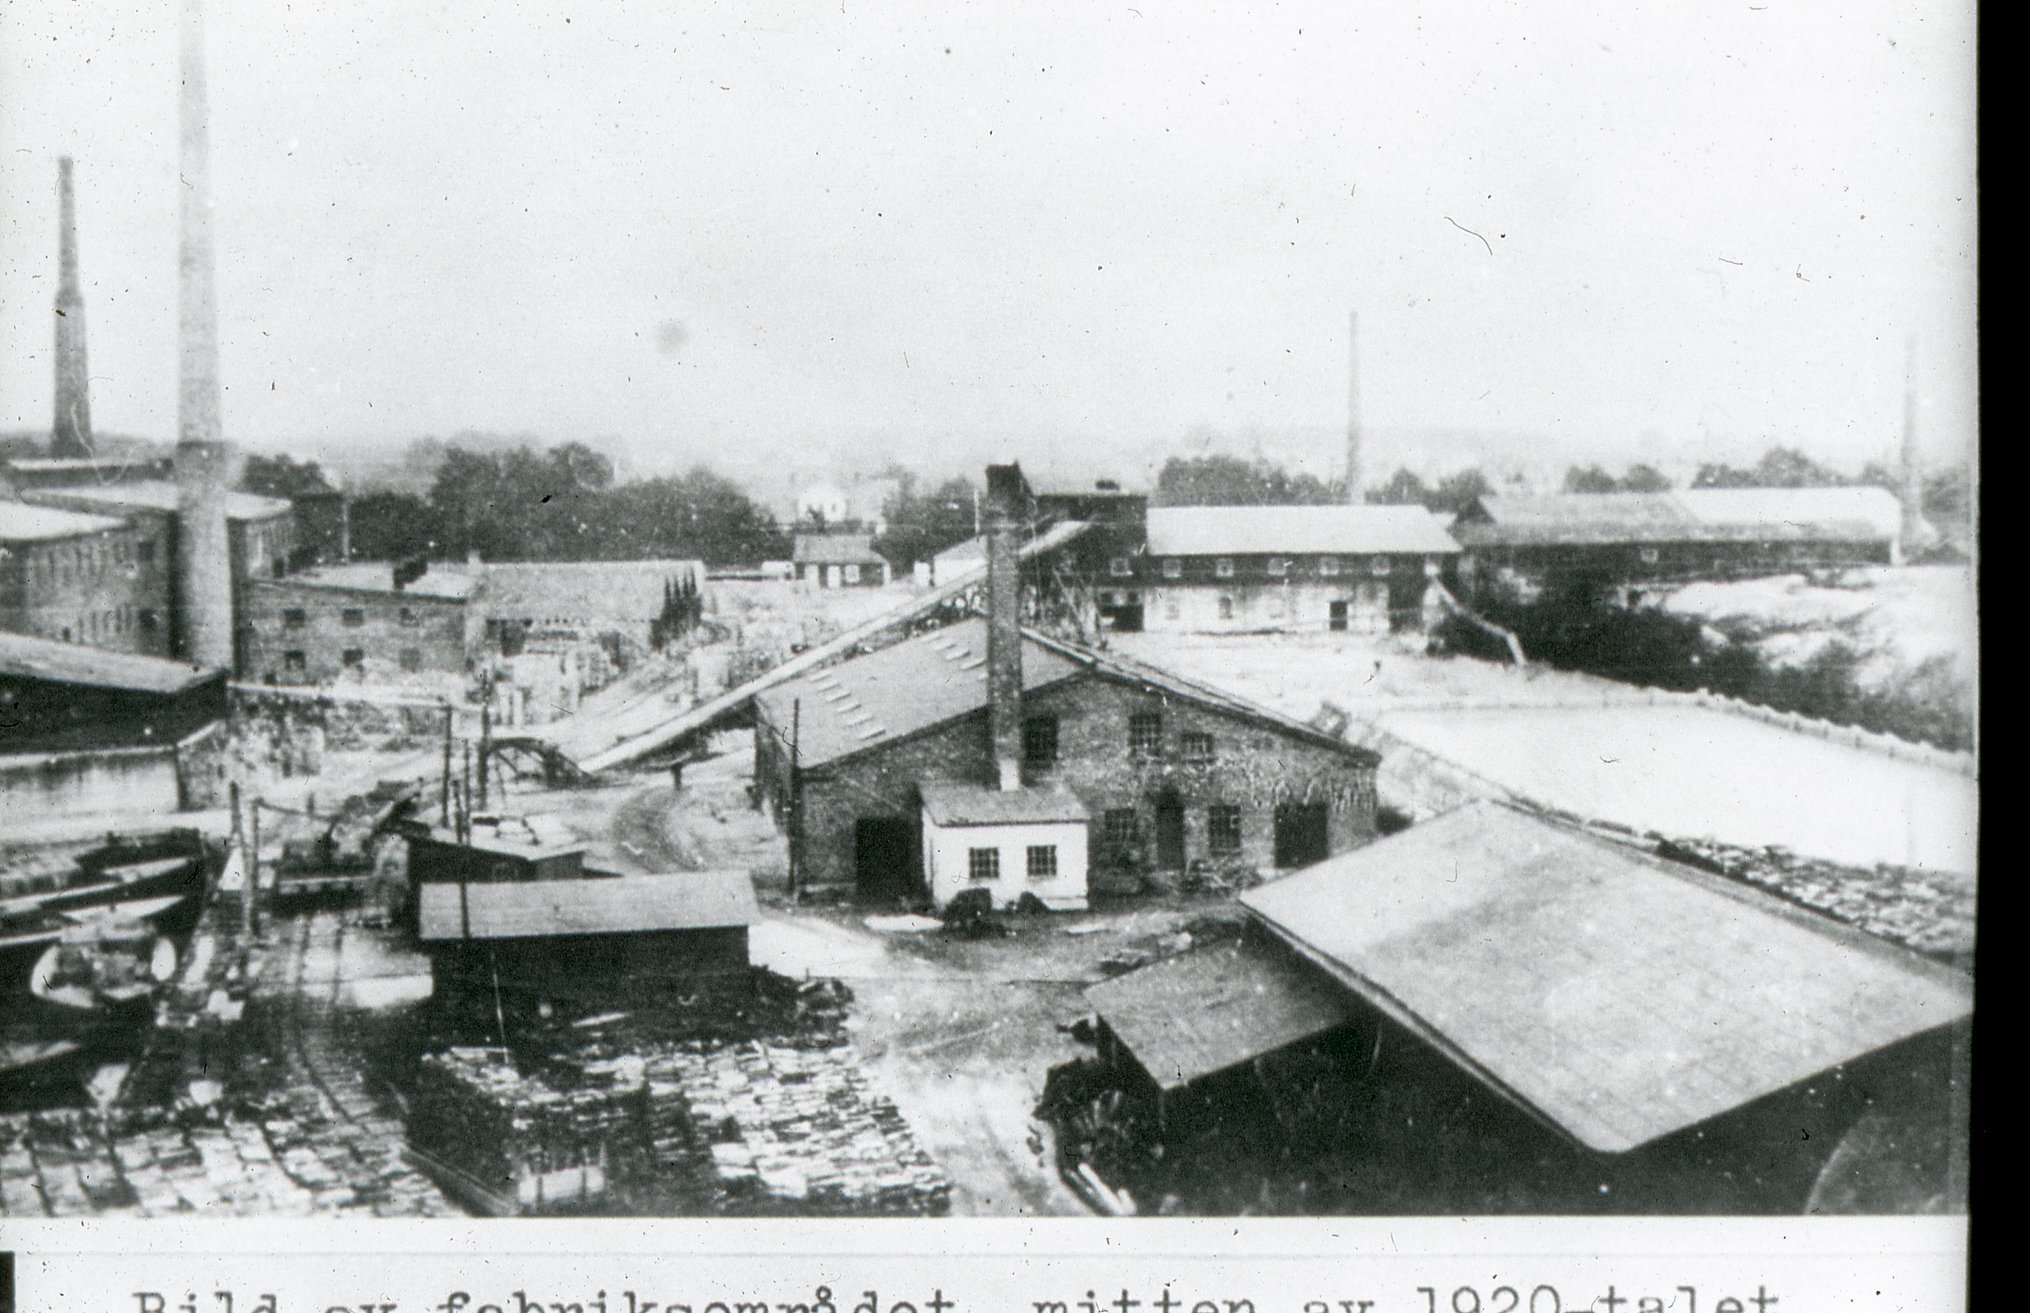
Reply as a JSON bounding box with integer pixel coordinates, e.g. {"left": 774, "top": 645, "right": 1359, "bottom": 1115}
{"left": 1656, "top": 838, "right": 1975, "bottom": 964}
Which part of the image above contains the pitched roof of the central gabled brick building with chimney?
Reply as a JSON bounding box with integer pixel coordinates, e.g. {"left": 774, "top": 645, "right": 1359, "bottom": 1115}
{"left": 755, "top": 617, "right": 1380, "bottom": 767}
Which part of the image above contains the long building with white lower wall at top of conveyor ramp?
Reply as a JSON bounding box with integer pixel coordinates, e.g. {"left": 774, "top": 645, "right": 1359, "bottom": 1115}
{"left": 1108, "top": 505, "right": 1460, "bottom": 633}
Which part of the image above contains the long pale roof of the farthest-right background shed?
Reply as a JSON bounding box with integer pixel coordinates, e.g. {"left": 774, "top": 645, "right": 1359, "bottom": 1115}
{"left": 1453, "top": 487, "right": 1902, "bottom": 546}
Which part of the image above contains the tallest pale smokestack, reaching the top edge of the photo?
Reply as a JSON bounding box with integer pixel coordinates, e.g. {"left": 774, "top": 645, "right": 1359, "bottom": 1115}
{"left": 177, "top": 0, "right": 233, "bottom": 668}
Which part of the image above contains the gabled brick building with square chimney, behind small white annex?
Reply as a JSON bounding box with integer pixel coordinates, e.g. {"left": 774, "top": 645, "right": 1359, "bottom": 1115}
{"left": 755, "top": 467, "right": 1378, "bottom": 901}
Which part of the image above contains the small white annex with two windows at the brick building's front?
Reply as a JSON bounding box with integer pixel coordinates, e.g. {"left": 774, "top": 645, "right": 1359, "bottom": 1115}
{"left": 922, "top": 783, "right": 1090, "bottom": 911}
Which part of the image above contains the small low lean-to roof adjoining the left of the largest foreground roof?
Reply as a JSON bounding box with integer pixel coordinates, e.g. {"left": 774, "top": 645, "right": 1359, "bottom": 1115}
{"left": 1086, "top": 940, "right": 1352, "bottom": 1090}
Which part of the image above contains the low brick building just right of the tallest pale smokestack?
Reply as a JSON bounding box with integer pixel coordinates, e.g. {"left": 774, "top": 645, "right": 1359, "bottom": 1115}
{"left": 240, "top": 562, "right": 485, "bottom": 684}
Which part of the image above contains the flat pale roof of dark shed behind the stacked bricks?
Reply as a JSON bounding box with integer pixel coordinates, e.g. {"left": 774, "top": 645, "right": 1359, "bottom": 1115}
{"left": 418, "top": 871, "right": 757, "bottom": 944}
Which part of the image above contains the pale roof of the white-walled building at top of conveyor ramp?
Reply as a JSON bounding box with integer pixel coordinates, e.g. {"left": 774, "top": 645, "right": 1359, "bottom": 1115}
{"left": 1149, "top": 505, "right": 1460, "bottom": 556}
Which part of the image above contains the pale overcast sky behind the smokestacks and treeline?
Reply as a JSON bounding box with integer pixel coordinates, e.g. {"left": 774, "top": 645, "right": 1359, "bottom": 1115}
{"left": 0, "top": 0, "right": 1977, "bottom": 475}
